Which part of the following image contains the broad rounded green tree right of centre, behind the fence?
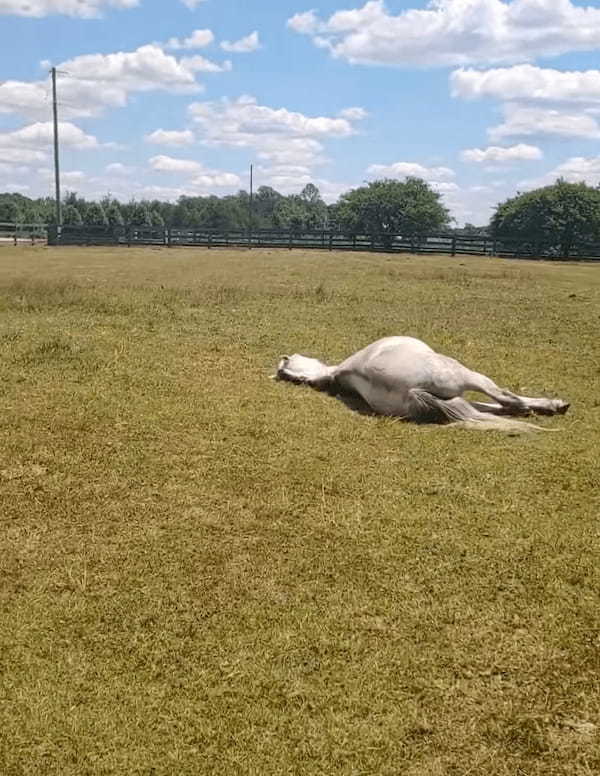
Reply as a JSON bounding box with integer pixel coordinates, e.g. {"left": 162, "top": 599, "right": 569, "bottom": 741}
{"left": 335, "top": 178, "right": 450, "bottom": 237}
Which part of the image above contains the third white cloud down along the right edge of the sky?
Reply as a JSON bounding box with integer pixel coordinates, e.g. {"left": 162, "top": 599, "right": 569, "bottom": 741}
{"left": 488, "top": 103, "right": 600, "bottom": 142}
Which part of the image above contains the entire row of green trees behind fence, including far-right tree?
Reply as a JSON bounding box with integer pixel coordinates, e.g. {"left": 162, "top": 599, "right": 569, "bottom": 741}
{"left": 0, "top": 177, "right": 600, "bottom": 256}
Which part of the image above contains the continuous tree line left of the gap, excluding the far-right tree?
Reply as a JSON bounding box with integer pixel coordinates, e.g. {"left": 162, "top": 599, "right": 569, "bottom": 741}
{"left": 0, "top": 178, "right": 451, "bottom": 234}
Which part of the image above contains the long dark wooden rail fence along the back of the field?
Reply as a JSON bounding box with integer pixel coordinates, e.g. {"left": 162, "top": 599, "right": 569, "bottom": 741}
{"left": 14, "top": 224, "right": 600, "bottom": 261}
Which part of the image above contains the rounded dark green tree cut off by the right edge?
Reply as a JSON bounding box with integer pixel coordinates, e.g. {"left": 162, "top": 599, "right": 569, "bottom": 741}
{"left": 491, "top": 179, "right": 600, "bottom": 257}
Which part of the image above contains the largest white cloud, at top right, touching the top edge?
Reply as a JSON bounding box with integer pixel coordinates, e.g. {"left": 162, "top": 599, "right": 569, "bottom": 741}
{"left": 288, "top": 0, "right": 600, "bottom": 67}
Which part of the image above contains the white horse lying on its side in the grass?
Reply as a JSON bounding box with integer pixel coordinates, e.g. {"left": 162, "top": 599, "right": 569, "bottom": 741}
{"left": 276, "top": 337, "right": 569, "bottom": 431}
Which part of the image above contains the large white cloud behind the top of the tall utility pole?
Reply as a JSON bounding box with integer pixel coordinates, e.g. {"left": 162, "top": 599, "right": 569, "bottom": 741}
{"left": 0, "top": 43, "right": 220, "bottom": 118}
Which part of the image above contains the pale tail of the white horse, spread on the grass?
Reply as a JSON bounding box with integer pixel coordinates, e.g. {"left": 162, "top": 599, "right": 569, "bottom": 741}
{"left": 410, "top": 388, "right": 550, "bottom": 433}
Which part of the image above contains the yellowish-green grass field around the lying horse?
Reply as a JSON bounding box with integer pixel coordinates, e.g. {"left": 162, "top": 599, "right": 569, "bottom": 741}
{"left": 0, "top": 247, "right": 600, "bottom": 776}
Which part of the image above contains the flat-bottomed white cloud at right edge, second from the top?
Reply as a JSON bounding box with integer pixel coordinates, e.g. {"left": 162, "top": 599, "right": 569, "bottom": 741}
{"left": 450, "top": 65, "right": 600, "bottom": 104}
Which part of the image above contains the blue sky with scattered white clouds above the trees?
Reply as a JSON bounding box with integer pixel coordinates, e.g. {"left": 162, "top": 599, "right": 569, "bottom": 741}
{"left": 0, "top": 0, "right": 600, "bottom": 224}
